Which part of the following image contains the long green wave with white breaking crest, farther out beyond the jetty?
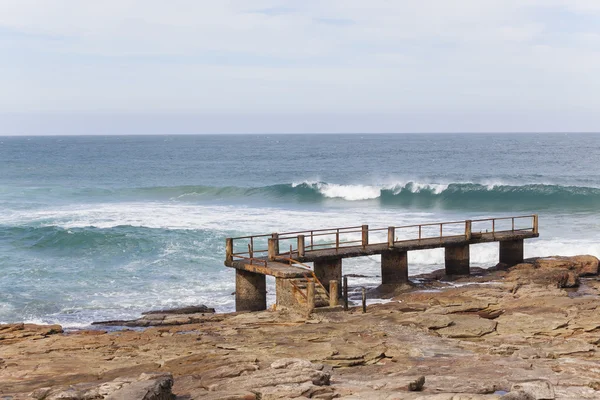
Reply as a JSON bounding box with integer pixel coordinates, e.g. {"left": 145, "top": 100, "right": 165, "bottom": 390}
{"left": 136, "top": 181, "right": 600, "bottom": 209}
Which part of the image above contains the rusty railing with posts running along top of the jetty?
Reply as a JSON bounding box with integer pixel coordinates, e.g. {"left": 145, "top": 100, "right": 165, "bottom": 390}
{"left": 225, "top": 214, "right": 538, "bottom": 267}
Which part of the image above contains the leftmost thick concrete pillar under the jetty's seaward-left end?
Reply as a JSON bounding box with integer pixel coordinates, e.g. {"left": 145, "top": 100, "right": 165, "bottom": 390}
{"left": 235, "top": 269, "right": 267, "bottom": 311}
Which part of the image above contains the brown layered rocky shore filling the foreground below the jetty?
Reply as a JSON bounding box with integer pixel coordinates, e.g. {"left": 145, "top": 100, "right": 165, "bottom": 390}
{"left": 0, "top": 256, "right": 600, "bottom": 400}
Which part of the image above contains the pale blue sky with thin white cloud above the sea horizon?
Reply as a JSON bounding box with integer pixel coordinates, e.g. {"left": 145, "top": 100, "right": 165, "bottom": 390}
{"left": 0, "top": 0, "right": 600, "bottom": 135}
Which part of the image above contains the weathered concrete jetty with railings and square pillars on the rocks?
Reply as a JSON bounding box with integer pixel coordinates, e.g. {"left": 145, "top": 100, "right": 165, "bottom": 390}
{"left": 225, "top": 215, "right": 539, "bottom": 311}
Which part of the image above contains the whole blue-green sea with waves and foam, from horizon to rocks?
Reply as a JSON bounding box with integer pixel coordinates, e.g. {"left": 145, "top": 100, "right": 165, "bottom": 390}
{"left": 0, "top": 134, "right": 600, "bottom": 327}
